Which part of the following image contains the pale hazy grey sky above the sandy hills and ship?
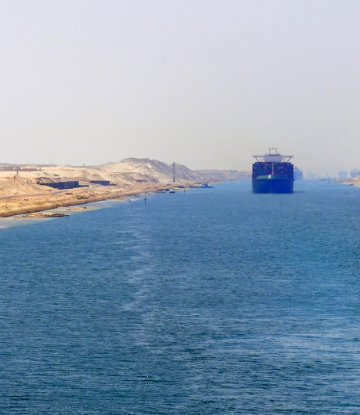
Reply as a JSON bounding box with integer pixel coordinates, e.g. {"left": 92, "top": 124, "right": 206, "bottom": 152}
{"left": 0, "top": 0, "right": 360, "bottom": 174}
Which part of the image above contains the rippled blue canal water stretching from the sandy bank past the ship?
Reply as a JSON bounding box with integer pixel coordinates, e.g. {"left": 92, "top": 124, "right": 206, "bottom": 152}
{"left": 0, "top": 181, "right": 360, "bottom": 415}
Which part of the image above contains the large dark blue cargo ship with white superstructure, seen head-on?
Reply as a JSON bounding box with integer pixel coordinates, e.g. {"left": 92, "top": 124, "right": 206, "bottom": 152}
{"left": 252, "top": 148, "right": 294, "bottom": 193}
